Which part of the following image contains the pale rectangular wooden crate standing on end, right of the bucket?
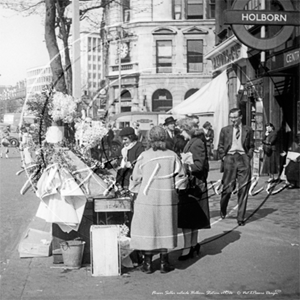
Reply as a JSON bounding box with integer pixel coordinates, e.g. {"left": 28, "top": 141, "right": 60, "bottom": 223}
{"left": 90, "top": 225, "right": 121, "bottom": 276}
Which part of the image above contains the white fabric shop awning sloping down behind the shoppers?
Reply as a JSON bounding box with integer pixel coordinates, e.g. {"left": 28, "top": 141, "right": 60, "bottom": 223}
{"left": 170, "top": 70, "right": 228, "bottom": 149}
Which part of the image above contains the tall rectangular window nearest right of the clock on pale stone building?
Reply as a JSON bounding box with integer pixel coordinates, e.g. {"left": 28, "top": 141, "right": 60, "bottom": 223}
{"left": 156, "top": 41, "right": 172, "bottom": 73}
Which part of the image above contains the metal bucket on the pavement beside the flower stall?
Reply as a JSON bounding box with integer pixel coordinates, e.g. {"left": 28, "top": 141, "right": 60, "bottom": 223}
{"left": 60, "top": 240, "right": 85, "bottom": 269}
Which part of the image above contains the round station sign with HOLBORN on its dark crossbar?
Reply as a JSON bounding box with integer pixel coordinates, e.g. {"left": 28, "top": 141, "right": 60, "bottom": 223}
{"left": 224, "top": 0, "right": 300, "bottom": 50}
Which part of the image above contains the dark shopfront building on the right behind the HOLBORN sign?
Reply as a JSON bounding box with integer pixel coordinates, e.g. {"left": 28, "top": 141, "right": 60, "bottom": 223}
{"left": 205, "top": 0, "right": 300, "bottom": 153}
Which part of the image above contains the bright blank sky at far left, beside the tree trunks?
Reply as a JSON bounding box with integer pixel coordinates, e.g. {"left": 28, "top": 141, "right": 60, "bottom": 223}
{"left": 0, "top": 8, "right": 49, "bottom": 85}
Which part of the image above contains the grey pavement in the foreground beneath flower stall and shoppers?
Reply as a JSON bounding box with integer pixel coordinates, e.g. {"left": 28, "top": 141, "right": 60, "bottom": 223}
{"left": 1, "top": 158, "right": 300, "bottom": 300}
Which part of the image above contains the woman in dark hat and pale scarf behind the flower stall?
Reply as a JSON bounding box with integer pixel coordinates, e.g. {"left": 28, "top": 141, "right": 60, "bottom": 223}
{"left": 116, "top": 127, "right": 144, "bottom": 189}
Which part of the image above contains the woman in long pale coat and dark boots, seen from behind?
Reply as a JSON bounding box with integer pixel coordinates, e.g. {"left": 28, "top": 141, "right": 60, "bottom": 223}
{"left": 130, "top": 126, "right": 186, "bottom": 274}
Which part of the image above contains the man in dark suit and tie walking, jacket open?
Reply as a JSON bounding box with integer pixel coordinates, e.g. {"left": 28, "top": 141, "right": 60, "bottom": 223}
{"left": 218, "top": 108, "right": 254, "bottom": 226}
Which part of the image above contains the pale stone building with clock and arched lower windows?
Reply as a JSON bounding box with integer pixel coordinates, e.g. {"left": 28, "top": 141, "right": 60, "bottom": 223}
{"left": 102, "top": 0, "right": 215, "bottom": 113}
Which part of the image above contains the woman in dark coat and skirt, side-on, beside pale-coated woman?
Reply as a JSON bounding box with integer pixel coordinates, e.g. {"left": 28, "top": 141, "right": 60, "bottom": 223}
{"left": 178, "top": 118, "right": 210, "bottom": 260}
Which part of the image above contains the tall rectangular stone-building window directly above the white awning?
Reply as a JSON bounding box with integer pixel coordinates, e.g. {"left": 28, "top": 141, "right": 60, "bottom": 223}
{"left": 187, "top": 40, "right": 203, "bottom": 73}
